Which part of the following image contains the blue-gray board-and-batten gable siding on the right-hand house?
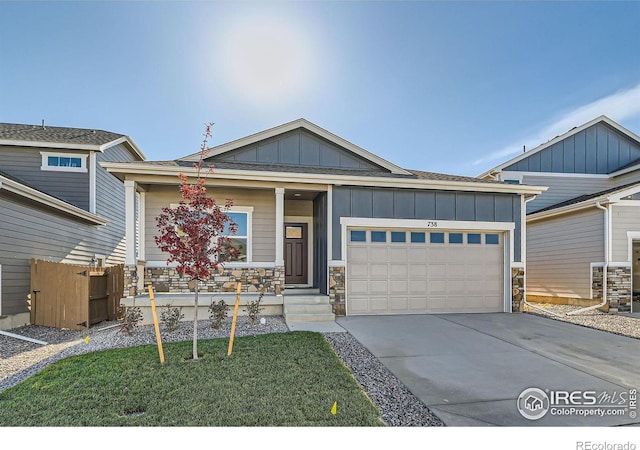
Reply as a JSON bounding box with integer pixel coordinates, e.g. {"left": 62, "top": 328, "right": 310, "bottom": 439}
{"left": 502, "top": 123, "right": 640, "bottom": 174}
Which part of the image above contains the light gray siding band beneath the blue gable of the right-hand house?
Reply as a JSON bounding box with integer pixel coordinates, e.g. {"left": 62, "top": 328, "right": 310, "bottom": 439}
{"left": 516, "top": 174, "right": 613, "bottom": 213}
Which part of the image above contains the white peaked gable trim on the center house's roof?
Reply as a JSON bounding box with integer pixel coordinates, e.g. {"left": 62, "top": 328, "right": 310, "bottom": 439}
{"left": 180, "top": 119, "right": 411, "bottom": 175}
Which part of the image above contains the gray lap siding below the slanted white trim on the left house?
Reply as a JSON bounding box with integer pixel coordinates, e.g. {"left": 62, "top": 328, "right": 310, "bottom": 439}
{"left": 0, "top": 190, "right": 113, "bottom": 315}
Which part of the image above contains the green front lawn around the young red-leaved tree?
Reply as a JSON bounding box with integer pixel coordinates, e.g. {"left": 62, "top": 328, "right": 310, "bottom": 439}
{"left": 0, "top": 332, "right": 384, "bottom": 427}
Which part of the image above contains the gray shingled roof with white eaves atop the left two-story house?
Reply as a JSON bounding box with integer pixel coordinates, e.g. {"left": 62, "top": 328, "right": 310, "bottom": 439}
{"left": 0, "top": 123, "right": 145, "bottom": 160}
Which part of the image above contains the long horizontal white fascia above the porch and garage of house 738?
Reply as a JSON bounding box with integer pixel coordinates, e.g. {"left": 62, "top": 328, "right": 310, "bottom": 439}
{"left": 101, "top": 163, "right": 548, "bottom": 195}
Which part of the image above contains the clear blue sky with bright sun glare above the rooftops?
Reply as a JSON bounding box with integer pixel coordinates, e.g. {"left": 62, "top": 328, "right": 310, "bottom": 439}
{"left": 0, "top": 1, "right": 640, "bottom": 175}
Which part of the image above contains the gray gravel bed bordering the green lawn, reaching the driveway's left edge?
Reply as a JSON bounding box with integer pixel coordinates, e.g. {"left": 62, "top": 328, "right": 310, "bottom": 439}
{"left": 0, "top": 316, "right": 444, "bottom": 427}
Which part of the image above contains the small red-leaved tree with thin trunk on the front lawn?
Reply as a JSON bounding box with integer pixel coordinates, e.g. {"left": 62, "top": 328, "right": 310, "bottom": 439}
{"left": 155, "top": 123, "right": 237, "bottom": 359}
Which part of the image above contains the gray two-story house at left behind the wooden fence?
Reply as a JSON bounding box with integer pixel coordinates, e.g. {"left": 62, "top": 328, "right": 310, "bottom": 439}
{"left": 0, "top": 123, "right": 144, "bottom": 329}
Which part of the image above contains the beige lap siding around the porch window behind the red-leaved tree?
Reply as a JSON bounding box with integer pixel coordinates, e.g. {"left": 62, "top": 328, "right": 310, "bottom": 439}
{"left": 145, "top": 185, "right": 276, "bottom": 263}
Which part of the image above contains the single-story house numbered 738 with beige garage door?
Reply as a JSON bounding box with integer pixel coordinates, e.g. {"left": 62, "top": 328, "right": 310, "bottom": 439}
{"left": 103, "top": 119, "right": 544, "bottom": 315}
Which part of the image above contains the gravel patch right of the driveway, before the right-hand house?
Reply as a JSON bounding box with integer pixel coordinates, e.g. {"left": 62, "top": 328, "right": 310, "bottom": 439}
{"left": 524, "top": 303, "right": 640, "bottom": 339}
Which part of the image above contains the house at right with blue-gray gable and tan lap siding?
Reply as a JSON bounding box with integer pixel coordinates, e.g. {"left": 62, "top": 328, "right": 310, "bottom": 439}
{"left": 480, "top": 116, "right": 640, "bottom": 311}
